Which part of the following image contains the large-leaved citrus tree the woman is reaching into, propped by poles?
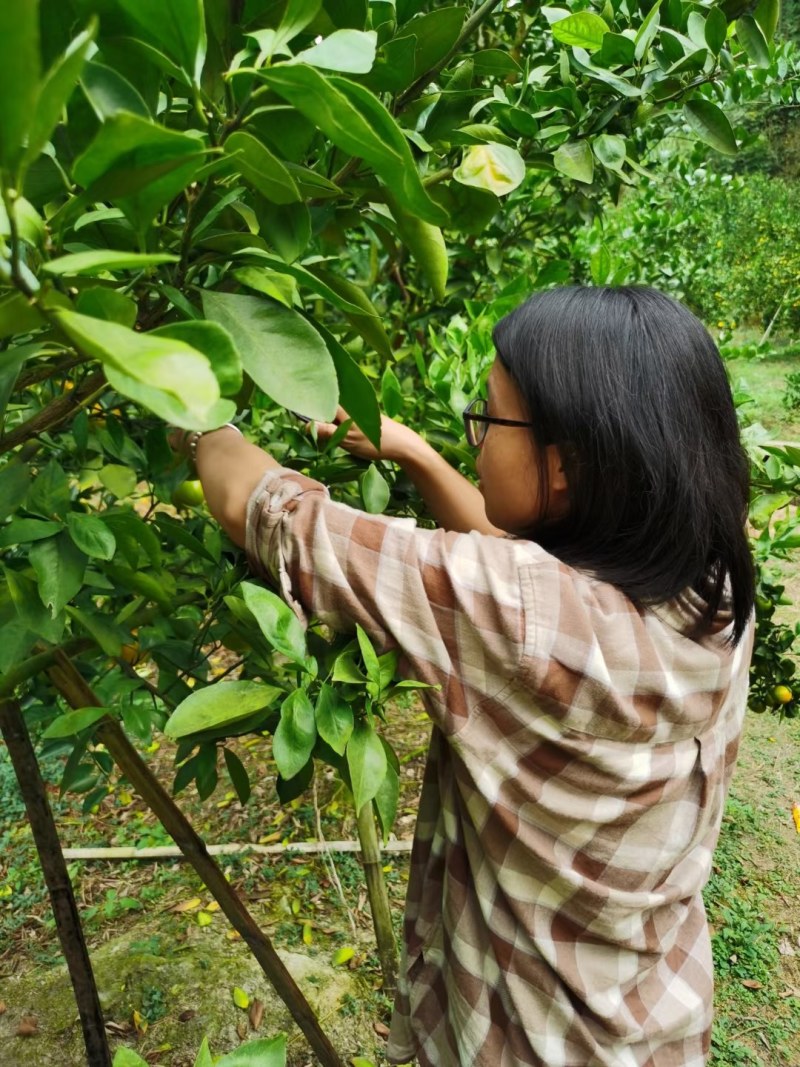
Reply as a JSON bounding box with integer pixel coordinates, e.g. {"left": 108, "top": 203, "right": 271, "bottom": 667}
{"left": 0, "top": 0, "right": 789, "bottom": 1062}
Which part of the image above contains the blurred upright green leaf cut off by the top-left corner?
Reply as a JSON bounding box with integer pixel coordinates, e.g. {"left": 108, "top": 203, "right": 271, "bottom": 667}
{"left": 0, "top": 0, "right": 39, "bottom": 176}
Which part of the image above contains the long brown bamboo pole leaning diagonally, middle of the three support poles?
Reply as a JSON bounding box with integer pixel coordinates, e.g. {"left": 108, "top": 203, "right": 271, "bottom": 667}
{"left": 49, "top": 653, "right": 343, "bottom": 1067}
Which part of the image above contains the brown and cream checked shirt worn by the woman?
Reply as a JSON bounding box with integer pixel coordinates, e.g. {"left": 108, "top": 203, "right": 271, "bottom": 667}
{"left": 247, "top": 469, "right": 752, "bottom": 1067}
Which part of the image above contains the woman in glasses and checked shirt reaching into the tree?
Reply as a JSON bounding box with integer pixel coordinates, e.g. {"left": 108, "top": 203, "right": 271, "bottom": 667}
{"left": 174, "top": 288, "right": 753, "bottom": 1067}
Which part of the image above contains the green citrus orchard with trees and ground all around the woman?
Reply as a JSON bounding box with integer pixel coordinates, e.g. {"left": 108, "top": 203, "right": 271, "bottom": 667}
{"left": 0, "top": 0, "right": 800, "bottom": 1067}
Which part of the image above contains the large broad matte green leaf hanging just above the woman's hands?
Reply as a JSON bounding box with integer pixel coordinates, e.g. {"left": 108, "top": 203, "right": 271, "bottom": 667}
{"left": 203, "top": 291, "right": 338, "bottom": 423}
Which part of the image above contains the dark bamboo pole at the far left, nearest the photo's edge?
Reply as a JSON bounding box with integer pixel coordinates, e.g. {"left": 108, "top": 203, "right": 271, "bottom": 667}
{"left": 0, "top": 700, "right": 111, "bottom": 1067}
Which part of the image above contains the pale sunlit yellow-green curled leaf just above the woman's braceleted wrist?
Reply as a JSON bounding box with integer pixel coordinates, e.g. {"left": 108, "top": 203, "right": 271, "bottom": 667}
{"left": 55, "top": 310, "right": 225, "bottom": 429}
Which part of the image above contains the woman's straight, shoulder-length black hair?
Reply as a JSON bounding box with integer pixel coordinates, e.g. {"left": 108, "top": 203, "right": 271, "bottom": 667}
{"left": 494, "top": 286, "right": 754, "bottom": 643}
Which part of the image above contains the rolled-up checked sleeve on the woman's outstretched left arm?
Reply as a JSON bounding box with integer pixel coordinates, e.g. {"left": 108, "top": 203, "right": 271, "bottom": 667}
{"left": 246, "top": 468, "right": 533, "bottom": 732}
